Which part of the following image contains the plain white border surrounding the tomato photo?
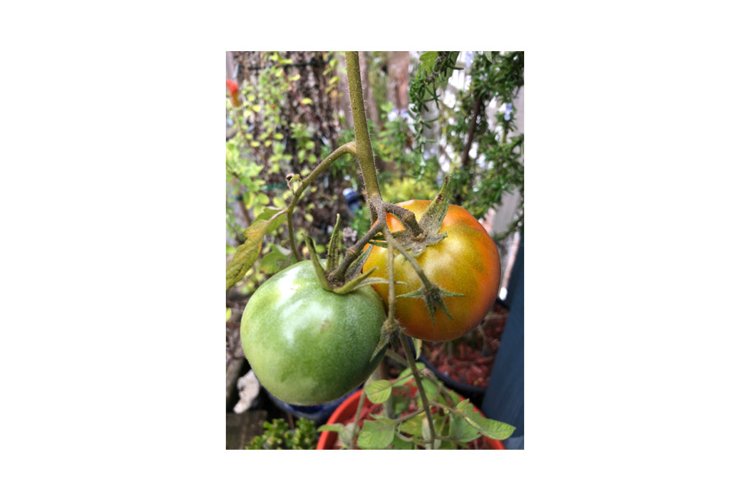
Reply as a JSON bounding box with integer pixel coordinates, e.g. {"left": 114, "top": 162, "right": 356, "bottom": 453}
{"left": 0, "top": 1, "right": 750, "bottom": 499}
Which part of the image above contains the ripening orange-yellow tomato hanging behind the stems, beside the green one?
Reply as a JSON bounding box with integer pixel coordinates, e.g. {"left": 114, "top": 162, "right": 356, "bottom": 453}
{"left": 363, "top": 200, "right": 500, "bottom": 341}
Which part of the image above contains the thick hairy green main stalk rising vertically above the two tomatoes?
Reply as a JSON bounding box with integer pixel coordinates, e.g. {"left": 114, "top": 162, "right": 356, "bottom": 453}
{"left": 346, "top": 52, "right": 380, "bottom": 223}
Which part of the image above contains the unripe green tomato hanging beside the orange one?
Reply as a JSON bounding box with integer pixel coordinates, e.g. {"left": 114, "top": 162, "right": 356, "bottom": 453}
{"left": 240, "top": 260, "right": 385, "bottom": 405}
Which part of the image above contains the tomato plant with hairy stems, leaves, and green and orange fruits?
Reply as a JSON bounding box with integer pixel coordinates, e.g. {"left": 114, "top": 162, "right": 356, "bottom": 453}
{"left": 226, "top": 52, "right": 514, "bottom": 449}
